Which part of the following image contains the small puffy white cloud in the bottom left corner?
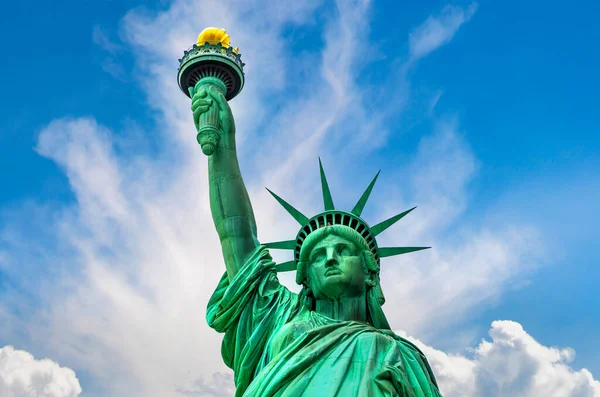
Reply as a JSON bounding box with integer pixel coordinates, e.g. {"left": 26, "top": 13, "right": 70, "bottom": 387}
{"left": 0, "top": 346, "right": 81, "bottom": 397}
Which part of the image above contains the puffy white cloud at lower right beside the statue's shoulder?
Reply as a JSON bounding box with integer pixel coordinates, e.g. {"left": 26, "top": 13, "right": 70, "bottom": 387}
{"left": 409, "top": 321, "right": 600, "bottom": 397}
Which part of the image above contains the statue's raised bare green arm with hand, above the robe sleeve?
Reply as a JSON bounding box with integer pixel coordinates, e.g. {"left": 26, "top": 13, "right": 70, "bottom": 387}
{"left": 192, "top": 83, "right": 259, "bottom": 280}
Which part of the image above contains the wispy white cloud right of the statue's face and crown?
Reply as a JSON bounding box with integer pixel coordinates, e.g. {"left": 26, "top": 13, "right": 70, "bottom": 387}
{"left": 375, "top": 117, "right": 544, "bottom": 338}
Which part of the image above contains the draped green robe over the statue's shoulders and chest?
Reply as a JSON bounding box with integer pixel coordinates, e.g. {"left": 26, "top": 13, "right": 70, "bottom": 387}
{"left": 207, "top": 247, "right": 441, "bottom": 397}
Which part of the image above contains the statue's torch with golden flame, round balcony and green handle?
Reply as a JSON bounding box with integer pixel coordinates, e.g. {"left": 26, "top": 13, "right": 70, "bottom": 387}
{"left": 177, "top": 28, "right": 244, "bottom": 156}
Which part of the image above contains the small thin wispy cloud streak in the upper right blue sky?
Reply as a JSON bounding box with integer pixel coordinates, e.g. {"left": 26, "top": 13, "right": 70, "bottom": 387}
{"left": 408, "top": 3, "right": 477, "bottom": 60}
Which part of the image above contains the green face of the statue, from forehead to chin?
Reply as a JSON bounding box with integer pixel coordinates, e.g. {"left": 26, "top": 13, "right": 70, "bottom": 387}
{"left": 307, "top": 234, "right": 367, "bottom": 300}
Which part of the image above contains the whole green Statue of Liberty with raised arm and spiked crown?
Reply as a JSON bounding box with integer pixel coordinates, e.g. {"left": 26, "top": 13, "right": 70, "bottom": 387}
{"left": 180, "top": 31, "right": 441, "bottom": 397}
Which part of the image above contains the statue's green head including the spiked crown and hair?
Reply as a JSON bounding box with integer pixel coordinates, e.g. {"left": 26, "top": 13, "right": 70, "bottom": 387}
{"left": 263, "top": 160, "right": 429, "bottom": 329}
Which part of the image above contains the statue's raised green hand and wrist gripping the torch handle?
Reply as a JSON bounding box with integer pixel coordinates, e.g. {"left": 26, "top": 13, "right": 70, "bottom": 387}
{"left": 190, "top": 85, "right": 235, "bottom": 149}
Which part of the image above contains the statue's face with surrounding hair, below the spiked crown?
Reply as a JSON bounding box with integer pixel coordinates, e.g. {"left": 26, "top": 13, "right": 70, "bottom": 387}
{"left": 296, "top": 225, "right": 383, "bottom": 303}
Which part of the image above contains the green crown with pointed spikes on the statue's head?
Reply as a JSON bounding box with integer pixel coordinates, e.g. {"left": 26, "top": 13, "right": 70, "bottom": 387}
{"left": 263, "top": 159, "right": 431, "bottom": 272}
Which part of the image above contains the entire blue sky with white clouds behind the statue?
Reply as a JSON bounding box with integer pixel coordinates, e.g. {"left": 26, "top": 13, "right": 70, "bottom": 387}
{"left": 0, "top": 0, "right": 600, "bottom": 397}
